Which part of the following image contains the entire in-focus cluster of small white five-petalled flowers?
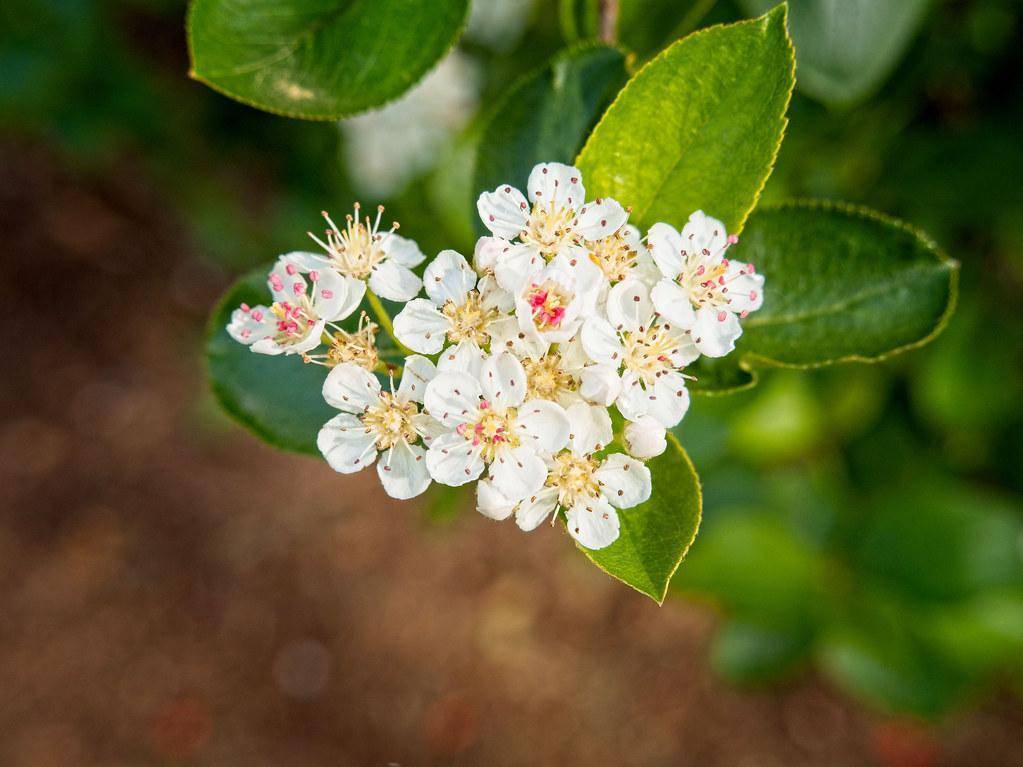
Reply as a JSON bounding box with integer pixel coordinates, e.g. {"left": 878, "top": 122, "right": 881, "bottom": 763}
{"left": 228, "top": 163, "right": 763, "bottom": 549}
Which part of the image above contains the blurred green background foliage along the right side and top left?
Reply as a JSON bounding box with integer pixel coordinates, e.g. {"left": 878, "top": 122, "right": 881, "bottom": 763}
{"left": 0, "top": 0, "right": 1023, "bottom": 718}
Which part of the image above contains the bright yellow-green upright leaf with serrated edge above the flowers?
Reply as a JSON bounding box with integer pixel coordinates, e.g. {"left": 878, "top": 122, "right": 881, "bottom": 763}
{"left": 577, "top": 6, "right": 795, "bottom": 231}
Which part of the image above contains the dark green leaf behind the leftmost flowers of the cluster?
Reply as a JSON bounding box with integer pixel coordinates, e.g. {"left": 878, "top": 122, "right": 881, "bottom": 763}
{"left": 206, "top": 268, "right": 338, "bottom": 456}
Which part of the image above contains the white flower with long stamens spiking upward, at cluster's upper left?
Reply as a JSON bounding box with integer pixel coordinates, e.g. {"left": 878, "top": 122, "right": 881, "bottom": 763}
{"left": 300, "top": 202, "right": 426, "bottom": 301}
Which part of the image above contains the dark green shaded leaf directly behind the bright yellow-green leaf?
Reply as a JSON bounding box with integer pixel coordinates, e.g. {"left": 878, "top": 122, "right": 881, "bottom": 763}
{"left": 474, "top": 44, "right": 628, "bottom": 233}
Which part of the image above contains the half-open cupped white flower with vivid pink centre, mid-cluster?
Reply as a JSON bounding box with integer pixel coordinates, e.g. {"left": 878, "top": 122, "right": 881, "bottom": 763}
{"left": 515, "top": 256, "right": 601, "bottom": 344}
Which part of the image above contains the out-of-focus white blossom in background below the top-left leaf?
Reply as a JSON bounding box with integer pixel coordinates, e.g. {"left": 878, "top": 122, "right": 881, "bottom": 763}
{"left": 341, "top": 50, "right": 481, "bottom": 198}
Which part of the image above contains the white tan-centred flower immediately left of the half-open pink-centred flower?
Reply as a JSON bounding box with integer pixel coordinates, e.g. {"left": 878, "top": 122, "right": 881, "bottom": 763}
{"left": 394, "top": 251, "right": 516, "bottom": 373}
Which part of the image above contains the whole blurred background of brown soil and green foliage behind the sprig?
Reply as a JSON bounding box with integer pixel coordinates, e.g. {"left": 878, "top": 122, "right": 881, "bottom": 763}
{"left": 0, "top": 0, "right": 1023, "bottom": 767}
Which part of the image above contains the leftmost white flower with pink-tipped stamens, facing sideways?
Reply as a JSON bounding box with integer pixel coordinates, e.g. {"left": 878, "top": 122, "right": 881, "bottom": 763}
{"left": 227, "top": 256, "right": 365, "bottom": 355}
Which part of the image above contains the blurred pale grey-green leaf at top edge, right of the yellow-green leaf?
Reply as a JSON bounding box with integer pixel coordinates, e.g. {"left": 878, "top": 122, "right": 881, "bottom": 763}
{"left": 742, "top": 0, "right": 930, "bottom": 105}
